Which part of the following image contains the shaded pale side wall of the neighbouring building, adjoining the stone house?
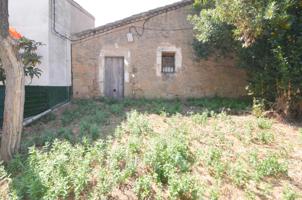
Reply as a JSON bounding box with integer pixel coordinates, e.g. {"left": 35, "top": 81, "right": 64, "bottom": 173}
{"left": 49, "top": 0, "right": 95, "bottom": 86}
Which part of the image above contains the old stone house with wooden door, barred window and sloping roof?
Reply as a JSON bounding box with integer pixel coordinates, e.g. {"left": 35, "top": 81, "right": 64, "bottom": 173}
{"left": 72, "top": 0, "right": 246, "bottom": 98}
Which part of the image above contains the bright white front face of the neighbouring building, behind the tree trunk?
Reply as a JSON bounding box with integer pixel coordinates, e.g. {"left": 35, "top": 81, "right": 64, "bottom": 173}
{"left": 8, "top": 0, "right": 49, "bottom": 85}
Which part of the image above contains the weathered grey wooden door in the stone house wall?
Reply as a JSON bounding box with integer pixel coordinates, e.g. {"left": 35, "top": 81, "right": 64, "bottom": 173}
{"left": 104, "top": 57, "right": 124, "bottom": 99}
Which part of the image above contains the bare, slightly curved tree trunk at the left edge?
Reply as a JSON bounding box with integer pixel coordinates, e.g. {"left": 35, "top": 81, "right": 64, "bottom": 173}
{"left": 0, "top": 0, "right": 25, "bottom": 162}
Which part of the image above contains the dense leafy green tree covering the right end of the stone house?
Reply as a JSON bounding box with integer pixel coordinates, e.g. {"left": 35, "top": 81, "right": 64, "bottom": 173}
{"left": 189, "top": 0, "right": 302, "bottom": 118}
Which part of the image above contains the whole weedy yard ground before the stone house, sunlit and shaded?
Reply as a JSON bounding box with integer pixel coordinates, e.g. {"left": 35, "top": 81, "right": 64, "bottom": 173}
{"left": 0, "top": 98, "right": 302, "bottom": 200}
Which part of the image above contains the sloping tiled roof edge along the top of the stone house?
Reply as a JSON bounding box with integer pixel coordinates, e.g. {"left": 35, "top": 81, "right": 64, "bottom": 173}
{"left": 73, "top": 0, "right": 194, "bottom": 39}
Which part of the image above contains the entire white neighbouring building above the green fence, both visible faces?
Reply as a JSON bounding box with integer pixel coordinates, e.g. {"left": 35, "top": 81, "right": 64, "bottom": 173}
{"left": 9, "top": 0, "right": 94, "bottom": 86}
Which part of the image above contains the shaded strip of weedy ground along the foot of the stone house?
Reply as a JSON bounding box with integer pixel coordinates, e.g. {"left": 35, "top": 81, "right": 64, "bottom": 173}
{"left": 21, "top": 98, "right": 251, "bottom": 153}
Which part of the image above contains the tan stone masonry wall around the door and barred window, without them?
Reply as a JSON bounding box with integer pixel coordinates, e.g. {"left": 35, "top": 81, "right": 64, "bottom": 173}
{"left": 72, "top": 6, "right": 246, "bottom": 98}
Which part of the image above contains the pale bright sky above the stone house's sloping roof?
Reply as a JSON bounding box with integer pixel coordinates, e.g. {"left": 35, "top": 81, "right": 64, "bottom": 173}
{"left": 75, "top": 0, "right": 179, "bottom": 26}
